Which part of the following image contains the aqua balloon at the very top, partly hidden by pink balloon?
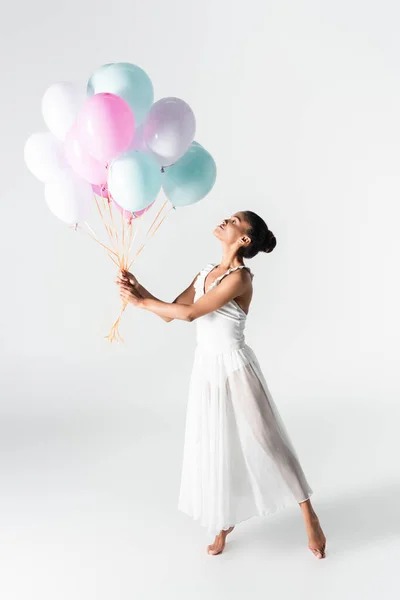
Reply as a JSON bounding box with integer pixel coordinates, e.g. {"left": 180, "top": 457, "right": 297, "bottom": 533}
{"left": 87, "top": 63, "right": 154, "bottom": 125}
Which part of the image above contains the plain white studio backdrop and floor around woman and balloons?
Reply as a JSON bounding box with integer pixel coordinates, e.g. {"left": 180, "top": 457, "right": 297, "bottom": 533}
{"left": 0, "top": 0, "right": 400, "bottom": 600}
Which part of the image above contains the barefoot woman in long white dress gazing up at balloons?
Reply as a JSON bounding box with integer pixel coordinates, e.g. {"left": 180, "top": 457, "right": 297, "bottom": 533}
{"left": 117, "top": 211, "right": 326, "bottom": 558}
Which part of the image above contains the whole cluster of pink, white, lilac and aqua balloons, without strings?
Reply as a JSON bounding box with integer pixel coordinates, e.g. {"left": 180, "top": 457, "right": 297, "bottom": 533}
{"left": 24, "top": 63, "right": 216, "bottom": 224}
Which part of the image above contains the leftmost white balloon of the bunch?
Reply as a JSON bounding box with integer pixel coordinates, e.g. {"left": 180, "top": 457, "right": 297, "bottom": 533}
{"left": 24, "top": 131, "right": 68, "bottom": 183}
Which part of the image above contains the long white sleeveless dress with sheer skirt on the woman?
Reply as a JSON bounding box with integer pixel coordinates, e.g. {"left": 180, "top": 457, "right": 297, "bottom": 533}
{"left": 178, "top": 263, "right": 313, "bottom": 535}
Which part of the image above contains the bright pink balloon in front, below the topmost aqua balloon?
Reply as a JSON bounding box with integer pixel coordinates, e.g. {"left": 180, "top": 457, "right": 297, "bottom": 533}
{"left": 78, "top": 94, "right": 135, "bottom": 163}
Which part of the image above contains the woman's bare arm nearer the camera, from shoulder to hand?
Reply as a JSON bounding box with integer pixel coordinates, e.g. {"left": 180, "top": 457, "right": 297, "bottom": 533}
{"left": 121, "top": 271, "right": 251, "bottom": 322}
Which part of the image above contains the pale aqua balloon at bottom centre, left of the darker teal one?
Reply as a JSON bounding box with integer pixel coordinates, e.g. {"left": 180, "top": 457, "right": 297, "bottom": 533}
{"left": 108, "top": 151, "right": 162, "bottom": 212}
